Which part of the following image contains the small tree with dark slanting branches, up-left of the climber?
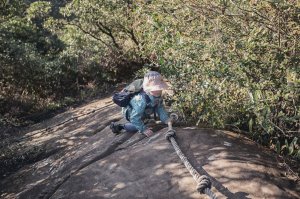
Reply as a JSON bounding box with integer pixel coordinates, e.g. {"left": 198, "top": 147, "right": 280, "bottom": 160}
{"left": 61, "top": 0, "right": 144, "bottom": 82}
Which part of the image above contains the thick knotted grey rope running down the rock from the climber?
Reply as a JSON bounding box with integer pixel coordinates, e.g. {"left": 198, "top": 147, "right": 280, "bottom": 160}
{"left": 166, "top": 116, "right": 217, "bottom": 199}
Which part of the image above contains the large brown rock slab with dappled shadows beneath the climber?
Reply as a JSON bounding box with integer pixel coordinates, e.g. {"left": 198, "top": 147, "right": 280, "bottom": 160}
{"left": 0, "top": 95, "right": 300, "bottom": 199}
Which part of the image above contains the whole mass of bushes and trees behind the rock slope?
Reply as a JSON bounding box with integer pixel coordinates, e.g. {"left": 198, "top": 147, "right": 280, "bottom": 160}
{"left": 0, "top": 0, "right": 300, "bottom": 160}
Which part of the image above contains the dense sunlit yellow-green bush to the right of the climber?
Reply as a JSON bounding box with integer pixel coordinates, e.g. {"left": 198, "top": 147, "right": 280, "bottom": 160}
{"left": 132, "top": 0, "right": 300, "bottom": 157}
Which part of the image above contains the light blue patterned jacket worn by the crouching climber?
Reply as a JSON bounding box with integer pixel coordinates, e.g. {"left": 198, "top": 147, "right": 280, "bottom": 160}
{"left": 122, "top": 93, "right": 169, "bottom": 133}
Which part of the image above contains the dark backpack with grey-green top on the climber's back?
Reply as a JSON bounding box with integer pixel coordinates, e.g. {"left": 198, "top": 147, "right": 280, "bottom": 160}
{"left": 112, "top": 79, "right": 151, "bottom": 107}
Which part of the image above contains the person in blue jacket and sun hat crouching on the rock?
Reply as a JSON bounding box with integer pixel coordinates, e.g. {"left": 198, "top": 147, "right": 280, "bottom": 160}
{"left": 110, "top": 71, "right": 170, "bottom": 137}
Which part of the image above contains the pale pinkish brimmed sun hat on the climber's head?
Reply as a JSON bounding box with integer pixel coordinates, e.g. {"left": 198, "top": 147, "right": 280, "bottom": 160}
{"left": 143, "top": 71, "right": 168, "bottom": 92}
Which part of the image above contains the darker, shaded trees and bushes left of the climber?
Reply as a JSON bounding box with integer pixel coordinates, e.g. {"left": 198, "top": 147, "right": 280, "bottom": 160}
{"left": 0, "top": 1, "right": 143, "bottom": 123}
